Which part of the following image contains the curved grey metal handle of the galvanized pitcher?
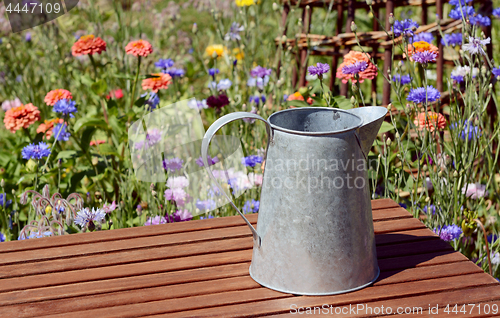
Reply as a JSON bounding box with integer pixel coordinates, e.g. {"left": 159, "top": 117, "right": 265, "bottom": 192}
{"left": 201, "top": 112, "right": 273, "bottom": 247}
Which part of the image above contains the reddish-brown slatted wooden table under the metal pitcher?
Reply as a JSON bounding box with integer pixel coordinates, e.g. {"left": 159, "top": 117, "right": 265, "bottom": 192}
{"left": 0, "top": 199, "right": 500, "bottom": 318}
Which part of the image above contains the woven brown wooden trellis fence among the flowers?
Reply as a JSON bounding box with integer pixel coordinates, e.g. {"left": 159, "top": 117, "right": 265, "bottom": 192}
{"left": 276, "top": 0, "right": 493, "bottom": 105}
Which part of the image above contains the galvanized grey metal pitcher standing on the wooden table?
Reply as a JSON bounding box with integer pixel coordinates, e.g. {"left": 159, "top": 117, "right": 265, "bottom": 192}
{"left": 201, "top": 106, "right": 387, "bottom": 295}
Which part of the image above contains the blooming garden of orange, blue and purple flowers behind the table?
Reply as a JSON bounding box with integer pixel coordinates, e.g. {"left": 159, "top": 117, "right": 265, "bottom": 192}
{"left": 0, "top": 0, "right": 500, "bottom": 278}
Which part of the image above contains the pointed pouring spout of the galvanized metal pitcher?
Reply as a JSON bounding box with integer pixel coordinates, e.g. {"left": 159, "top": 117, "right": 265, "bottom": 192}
{"left": 348, "top": 106, "right": 387, "bottom": 157}
